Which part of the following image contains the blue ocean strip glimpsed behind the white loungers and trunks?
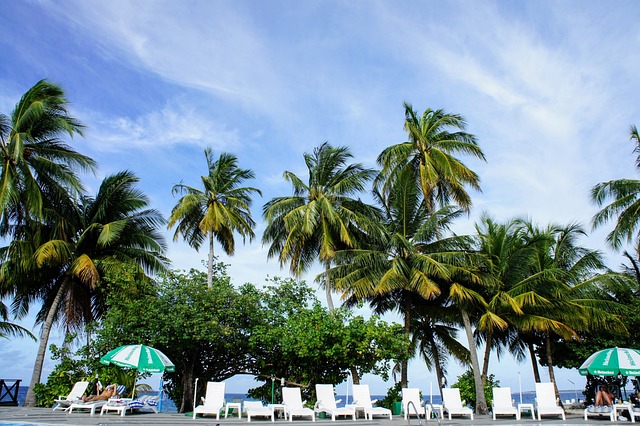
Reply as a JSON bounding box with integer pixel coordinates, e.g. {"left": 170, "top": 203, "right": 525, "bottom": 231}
{"left": 6, "top": 386, "right": 596, "bottom": 413}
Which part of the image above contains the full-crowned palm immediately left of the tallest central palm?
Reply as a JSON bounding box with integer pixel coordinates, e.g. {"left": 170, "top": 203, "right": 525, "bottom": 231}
{"left": 262, "top": 142, "right": 377, "bottom": 310}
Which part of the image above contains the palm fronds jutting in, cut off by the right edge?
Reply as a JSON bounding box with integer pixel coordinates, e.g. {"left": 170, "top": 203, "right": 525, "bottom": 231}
{"left": 591, "top": 126, "right": 640, "bottom": 250}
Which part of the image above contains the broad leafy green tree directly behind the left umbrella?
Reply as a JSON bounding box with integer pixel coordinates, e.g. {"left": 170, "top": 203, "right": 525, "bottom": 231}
{"left": 98, "top": 264, "right": 264, "bottom": 412}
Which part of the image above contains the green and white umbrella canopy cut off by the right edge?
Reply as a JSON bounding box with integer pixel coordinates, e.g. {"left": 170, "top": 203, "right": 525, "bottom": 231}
{"left": 578, "top": 347, "right": 640, "bottom": 376}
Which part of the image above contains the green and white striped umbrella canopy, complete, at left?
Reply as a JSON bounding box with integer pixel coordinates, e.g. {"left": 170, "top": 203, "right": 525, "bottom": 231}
{"left": 100, "top": 345, "right": 175, "bottom": 373}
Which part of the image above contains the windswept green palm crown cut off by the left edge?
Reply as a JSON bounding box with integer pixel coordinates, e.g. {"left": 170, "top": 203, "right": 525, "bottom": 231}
{"left": 0, "top": 80, "right": 96, "bottom": 236}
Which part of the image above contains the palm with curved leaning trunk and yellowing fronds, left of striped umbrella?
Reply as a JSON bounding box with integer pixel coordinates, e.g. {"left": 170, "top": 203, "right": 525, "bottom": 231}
{"left": 0, "top": 171, "right": 167, "bottom": 405}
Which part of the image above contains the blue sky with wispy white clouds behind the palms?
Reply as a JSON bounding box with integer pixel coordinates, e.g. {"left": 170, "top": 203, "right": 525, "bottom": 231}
{"left": 0, "top": 0, "right": 640, "bottom": 393}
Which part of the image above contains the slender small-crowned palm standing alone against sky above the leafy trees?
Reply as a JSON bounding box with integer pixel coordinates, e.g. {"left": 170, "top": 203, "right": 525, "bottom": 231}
{"left": 168, "top": 148, "right": 262, "bottom": 288}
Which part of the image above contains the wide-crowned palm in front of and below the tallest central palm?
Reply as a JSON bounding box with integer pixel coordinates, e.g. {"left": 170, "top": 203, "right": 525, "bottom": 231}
{"left": 332, "top": 170, "right": 476, "bottom": 387}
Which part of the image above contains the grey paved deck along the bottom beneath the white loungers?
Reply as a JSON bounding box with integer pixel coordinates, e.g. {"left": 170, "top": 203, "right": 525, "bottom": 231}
{"left": 0, "top": 407, "right": 630, "bottom": 426}
